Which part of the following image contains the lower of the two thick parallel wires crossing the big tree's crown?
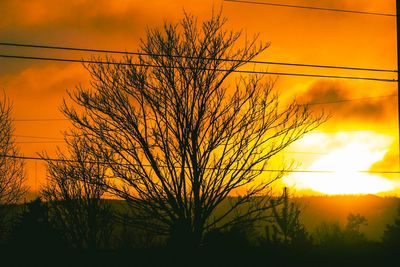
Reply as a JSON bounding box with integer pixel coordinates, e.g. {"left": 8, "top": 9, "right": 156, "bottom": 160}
{"left": 0, "top": 54, "right": 397, "bottom": 82}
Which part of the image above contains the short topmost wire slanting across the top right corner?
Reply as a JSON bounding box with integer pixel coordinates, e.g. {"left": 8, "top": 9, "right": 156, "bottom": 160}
{"left": 223, "top": 0, "right": 396, "bottom": 17}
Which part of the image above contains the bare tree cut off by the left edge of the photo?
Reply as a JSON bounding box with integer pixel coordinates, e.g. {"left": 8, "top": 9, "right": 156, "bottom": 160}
{"left": 0, "top": 97, "right": 26, "bottom": 240}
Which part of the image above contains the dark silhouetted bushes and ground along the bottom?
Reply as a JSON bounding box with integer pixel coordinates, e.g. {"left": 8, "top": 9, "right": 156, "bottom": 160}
{"left": 1, "top": 196, "right": 400, "bottom": 266}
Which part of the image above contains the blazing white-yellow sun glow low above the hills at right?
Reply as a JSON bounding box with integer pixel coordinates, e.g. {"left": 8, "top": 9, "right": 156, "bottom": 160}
{"left": 283, "top": 132, "right": 394, "bottom": 194}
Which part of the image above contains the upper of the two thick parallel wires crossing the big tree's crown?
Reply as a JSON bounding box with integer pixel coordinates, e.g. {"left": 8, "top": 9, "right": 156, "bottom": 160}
{"left": 0, "top": 42, "right": 397, "bottom": 72}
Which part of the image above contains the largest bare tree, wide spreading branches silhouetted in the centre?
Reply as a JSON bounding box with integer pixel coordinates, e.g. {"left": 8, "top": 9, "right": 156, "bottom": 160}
{"left": 63, "top": 14, "right": 325, "bottom": 247}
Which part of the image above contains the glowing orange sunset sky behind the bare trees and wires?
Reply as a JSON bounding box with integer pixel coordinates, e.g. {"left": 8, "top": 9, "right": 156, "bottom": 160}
{"left": 0, "top": 0, "right": 400, "bottom": 197}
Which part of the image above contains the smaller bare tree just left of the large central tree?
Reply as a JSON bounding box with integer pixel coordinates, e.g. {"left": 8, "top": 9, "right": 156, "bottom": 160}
{"left": 42, "top": 136, "right": 113, "bottom": 249}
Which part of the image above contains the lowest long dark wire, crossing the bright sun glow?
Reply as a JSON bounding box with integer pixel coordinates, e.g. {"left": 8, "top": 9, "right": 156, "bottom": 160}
{"left": 0, "top": 155, "right": 400, "bottom": 174}
